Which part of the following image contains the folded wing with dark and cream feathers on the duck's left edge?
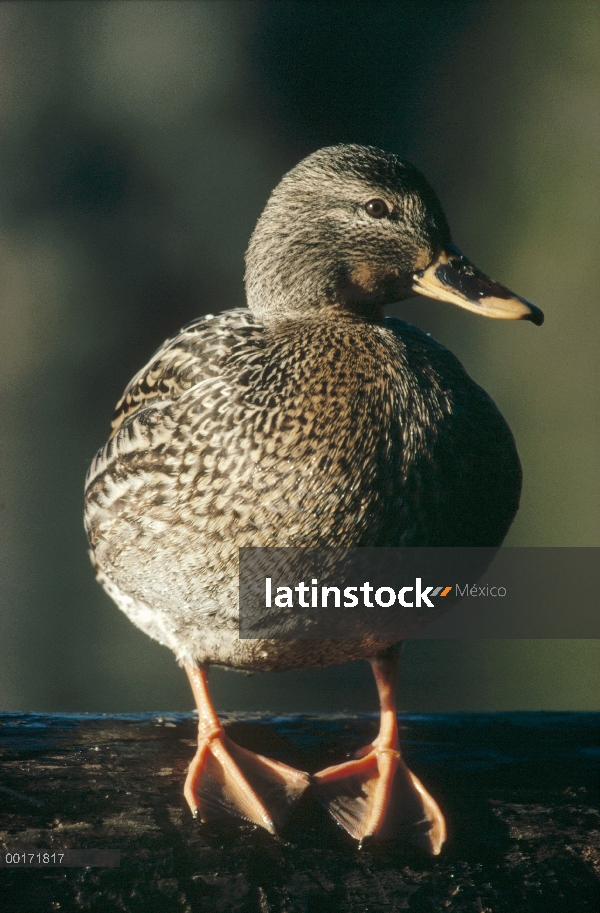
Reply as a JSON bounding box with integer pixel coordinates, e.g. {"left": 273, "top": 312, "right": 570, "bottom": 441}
{"left": 85, "top": 308, "right": 261, "bottom": 557}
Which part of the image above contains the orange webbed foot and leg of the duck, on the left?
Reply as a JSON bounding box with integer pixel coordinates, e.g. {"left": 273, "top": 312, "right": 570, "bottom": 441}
{"left": 183, "top": 665, "right": 309, "bottom": 834}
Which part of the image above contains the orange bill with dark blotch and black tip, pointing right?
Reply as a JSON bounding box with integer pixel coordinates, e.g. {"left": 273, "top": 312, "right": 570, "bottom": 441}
{"left": 412, "top": 245, "right": 544, "bottom": 326}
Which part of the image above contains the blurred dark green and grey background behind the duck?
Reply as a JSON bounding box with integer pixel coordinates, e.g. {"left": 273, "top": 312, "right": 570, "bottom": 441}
{"left": 0, "top": 0, "right": 600, "bottom": 711}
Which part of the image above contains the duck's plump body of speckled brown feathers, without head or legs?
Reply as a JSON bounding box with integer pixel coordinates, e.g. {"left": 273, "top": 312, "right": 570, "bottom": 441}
{"left": 86, "top": 310, "right": 520, "bottom": 670}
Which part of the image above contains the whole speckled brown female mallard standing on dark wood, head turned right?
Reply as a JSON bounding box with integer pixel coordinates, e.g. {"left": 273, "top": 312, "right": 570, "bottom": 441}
{"left": 86, "top": 145, "right": 543, "bottom": 853}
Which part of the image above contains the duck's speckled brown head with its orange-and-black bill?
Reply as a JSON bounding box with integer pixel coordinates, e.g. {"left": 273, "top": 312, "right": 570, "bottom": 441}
{"left": 245, "top": 145, "right": 544, "bottom": 325}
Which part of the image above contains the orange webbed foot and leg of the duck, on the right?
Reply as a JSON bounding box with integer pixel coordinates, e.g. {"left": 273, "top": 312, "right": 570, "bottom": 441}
{"left": 312, "top": 644, "right": 446, "bottom": 856}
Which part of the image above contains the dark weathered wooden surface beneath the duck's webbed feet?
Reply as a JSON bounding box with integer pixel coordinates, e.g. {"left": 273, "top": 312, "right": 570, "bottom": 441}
{"left": 0, "top": 713, "right": 600, "bottom": 913}
